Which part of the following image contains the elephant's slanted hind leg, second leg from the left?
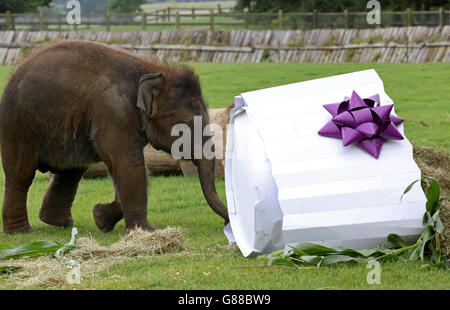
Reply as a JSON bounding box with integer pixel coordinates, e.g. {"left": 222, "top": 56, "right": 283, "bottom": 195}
{"left": 39, "top": 169, "right": 86, "bottom": 227}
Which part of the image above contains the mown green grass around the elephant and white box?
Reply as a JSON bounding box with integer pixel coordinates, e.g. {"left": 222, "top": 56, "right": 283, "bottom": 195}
{"left": 0, "top": 63, "right": 450, "bottom": 289}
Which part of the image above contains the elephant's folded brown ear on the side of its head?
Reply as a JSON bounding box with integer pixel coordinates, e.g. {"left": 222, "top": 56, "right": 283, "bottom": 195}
{"left": 136, "top": 73, "right": 164, "bottom": 131}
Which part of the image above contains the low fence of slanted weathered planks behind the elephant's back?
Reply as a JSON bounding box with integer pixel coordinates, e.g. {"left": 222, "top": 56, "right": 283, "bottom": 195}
{"left": 0, "top": 26, "right": 450, "bottom": 66}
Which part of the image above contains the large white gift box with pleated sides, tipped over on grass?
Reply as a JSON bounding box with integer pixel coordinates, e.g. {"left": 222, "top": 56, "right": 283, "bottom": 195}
{"left": 224, "top": 70, "right": 426, "bottom": 256}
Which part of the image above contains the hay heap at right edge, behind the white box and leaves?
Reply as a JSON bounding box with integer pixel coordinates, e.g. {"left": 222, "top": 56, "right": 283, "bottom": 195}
{"left": 414, "top": 146, "right": 450, "bottom": 256}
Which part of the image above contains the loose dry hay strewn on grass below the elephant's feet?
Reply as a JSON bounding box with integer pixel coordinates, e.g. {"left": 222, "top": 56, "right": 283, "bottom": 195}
{"left": 0, "top": 227, "right": 185, "bottom": 289}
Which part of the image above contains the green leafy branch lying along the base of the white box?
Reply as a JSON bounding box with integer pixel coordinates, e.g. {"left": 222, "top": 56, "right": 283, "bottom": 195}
{"left": 268, "top": 176, "right": 450, "bottom": 268}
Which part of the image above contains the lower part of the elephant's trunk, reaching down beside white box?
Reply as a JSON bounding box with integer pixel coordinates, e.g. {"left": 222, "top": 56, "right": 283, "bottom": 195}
{"left": 196, "top": 159, "right": 230, "bottom": 225}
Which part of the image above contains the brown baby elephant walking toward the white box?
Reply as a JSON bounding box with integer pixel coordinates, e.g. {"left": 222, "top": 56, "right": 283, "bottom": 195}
{"left": 0, "top": 41, "right": 228, "bottom": 234}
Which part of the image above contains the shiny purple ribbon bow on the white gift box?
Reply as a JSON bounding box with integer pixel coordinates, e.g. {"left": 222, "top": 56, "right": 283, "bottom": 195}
{"left": 318, "top": 91, "right": 404, "bottom": 158}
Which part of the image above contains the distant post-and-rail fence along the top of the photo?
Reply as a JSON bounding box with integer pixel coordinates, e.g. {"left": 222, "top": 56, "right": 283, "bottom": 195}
{"left": 0, "top": 7, "right": 450, "bottom": 31}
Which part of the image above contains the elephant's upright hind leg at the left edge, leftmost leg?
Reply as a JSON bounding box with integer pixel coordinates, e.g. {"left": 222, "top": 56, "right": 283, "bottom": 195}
{"left": 2, "top": 149, "right": 37, "bottom": 234}
